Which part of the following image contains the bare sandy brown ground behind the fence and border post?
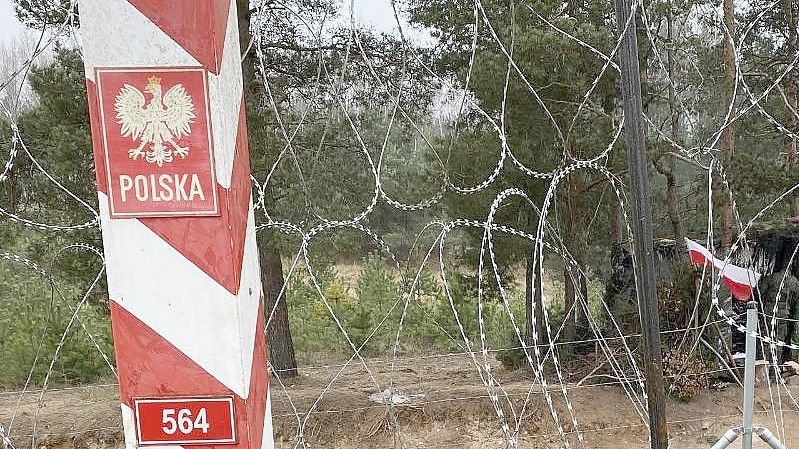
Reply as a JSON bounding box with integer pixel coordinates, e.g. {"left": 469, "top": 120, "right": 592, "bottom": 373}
{"left": 0, "top": 355, "right": 799, "bottom": 449}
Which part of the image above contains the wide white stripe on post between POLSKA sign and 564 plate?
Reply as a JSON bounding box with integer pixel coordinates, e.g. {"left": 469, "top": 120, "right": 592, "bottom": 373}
{"left": 98, "top": 192, "right": 261, "bottom": 399}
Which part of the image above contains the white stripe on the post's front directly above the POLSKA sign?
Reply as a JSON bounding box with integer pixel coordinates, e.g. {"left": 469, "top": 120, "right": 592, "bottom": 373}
{"left": 78, "top": 0, "right": 198, "bottom": 81}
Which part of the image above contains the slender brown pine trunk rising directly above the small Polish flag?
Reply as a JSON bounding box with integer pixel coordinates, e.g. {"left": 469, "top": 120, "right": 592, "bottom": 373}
{"left": 721, "top": 0, "right": 735, "bottom": 249}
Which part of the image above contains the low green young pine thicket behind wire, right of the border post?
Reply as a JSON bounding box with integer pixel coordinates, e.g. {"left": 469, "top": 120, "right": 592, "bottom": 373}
{"left": 288, "top": 254, "right": 524, "bottom": 362}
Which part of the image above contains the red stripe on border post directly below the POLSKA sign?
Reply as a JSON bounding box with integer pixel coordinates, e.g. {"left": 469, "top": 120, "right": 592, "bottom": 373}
{"left": 140, "top": 101, "right": 252, "bottom": 294}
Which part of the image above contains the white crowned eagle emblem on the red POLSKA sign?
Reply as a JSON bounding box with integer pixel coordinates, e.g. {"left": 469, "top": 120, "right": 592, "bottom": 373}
{"left": 114, "top": 76, "right": 196, "bottom": 167}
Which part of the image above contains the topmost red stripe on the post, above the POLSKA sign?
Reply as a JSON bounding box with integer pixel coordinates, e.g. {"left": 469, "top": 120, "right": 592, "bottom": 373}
{"left": 128, "top": 0, "right": 231, "bottom": 75}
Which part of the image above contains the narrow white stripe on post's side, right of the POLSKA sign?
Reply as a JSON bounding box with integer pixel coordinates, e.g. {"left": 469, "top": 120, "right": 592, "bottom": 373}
{"left": 208, "top": 3, "right": 243, "bottom": 189}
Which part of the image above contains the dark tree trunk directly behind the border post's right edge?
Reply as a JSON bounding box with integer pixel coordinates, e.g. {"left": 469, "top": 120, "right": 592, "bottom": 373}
{"left": 241, "top": 0, "right": 297, "bottom": 377}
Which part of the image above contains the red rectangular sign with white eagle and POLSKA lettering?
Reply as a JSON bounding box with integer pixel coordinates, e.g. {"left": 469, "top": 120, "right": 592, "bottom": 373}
{"left": 96, "top": 68, "right": 219, "bottom": 218}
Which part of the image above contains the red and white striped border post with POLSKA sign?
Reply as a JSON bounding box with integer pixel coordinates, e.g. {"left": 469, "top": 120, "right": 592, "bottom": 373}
{"left": 79, "top": 0, "right": 274, "bottom": 449}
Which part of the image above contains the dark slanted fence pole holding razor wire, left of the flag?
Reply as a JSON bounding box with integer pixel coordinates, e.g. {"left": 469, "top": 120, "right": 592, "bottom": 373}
{"left": 615, "top": 0, "right": 669, "bottom": 449}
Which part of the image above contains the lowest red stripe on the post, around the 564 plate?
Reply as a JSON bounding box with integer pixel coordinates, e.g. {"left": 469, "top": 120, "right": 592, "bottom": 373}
{"left": 111, "top": 301, "right": 269, "bottom": 449}
